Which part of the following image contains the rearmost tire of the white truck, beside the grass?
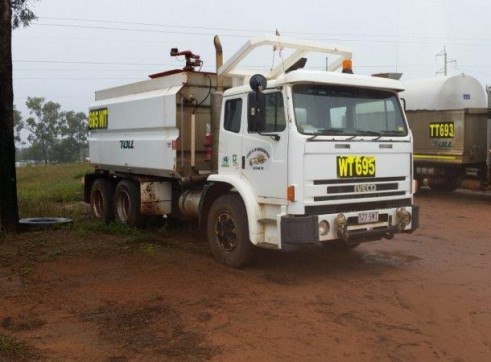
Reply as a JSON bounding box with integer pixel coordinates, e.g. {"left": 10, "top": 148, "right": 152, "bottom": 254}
{"left": 90, "top": 178, "right": 114, "bottom": 224}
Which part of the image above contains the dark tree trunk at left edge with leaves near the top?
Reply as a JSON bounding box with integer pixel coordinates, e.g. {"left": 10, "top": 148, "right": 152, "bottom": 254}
{"left": 0, "top": 0, "right": 35, "bottom": 232}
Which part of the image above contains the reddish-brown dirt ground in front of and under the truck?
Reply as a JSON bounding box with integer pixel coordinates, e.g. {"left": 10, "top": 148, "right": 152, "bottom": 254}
{"left": 0, "top": 192, "right": 491, "bottom": 361}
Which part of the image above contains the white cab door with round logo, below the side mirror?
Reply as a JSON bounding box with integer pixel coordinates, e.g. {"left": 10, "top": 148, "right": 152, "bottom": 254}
{"left": 241, "top": 91, "right": 288, "bottom": 199}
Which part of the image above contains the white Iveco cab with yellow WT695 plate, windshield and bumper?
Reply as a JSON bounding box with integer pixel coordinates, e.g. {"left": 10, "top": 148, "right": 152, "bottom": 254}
{"left": 209, "top": 40, "right": 418, "bottom": 258}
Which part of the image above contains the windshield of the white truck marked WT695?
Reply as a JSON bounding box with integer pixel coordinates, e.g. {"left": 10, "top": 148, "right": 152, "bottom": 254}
{"left": 293, "top": 84, "right": 408, "bottom": 137}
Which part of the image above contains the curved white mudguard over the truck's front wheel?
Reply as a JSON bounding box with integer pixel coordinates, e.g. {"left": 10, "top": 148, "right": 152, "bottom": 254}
{"left": 208, "top": 174, "right": 264, "bottom": 245}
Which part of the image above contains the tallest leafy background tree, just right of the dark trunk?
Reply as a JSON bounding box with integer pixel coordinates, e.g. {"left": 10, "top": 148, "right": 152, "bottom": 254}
{"left": 24, "top": 97, "right": 62, "bottom": 165}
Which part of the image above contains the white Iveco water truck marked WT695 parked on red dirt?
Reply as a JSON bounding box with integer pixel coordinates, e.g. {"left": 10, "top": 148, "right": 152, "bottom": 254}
{"left": 84, "top": 36, "right": 419, "bottom": 267}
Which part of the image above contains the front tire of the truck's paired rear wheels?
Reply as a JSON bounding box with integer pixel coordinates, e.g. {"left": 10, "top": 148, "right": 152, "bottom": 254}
{"left": 114, "top": 180, "right": 144, "bottom": 227}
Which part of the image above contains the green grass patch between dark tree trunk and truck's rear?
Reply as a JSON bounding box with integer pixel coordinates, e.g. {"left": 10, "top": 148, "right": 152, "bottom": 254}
{"left": 17, "top": 163, "right": 92, "bottom": 218}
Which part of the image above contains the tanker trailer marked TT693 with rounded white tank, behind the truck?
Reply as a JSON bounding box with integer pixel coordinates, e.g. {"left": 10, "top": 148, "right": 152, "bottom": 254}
{"left": 401, "top": 74, "right": 488, "bottom": 191}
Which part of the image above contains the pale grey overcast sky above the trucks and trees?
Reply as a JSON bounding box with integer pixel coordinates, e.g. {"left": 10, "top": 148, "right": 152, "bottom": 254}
{"left": 13, "top": 0, "right": 491, "bottom": 117}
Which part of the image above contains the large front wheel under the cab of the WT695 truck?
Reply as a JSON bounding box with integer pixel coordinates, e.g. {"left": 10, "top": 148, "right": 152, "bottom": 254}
{"left": 207, "top": 195, "right": 256, "bottom": 268}
